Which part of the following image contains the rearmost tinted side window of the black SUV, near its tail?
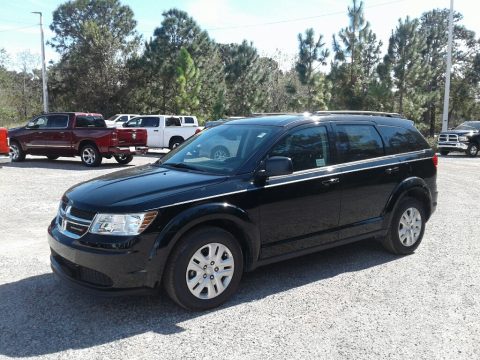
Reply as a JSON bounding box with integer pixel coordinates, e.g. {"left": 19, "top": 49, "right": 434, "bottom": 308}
{"left": 378, "top": 125, "right": 430, "bottom": 155}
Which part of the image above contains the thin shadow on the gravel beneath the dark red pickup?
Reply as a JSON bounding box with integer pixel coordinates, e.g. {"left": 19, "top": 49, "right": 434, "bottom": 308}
{"left": 2, "top": 159, "right": 139, "bottom": 171}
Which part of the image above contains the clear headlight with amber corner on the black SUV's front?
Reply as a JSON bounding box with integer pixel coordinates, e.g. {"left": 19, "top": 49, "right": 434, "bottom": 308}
{"left": 90, "top": 211, "right": 157, "bottom": 236}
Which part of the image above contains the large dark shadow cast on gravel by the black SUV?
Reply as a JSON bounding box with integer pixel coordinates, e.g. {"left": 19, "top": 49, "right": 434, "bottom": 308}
{"left": 0, "top": 240, "right": 398, "bottom": 357}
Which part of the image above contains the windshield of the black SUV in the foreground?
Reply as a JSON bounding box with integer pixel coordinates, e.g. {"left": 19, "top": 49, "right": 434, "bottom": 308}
{"left": 157, "top": 125, "right": 279, "bottom": 175}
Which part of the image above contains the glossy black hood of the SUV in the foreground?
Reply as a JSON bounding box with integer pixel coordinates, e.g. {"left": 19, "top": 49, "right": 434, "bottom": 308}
{"left": 65, "top": 164, "right": 227, "bottom": 213}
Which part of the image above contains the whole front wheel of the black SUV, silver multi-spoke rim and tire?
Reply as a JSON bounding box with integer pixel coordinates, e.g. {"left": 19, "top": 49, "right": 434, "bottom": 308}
{"left": 164, "top": 227, "right": 243, "bottom": 310}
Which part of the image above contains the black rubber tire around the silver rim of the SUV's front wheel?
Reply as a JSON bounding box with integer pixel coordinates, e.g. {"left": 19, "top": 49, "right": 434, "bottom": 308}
{"left": 163, "top": 226, "right": 243, "bottom": 310}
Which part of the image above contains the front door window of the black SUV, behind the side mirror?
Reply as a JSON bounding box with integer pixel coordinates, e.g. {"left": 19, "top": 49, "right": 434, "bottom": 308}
{"left": 269, "top": 126, "right": 330, "bottom": 171}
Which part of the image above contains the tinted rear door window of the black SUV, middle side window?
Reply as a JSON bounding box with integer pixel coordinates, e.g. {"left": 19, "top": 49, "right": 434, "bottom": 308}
{"left": 336, "top": 125, "right": 384, "bottom": 162}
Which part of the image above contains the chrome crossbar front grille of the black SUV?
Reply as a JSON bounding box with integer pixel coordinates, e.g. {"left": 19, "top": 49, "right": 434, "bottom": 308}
{"left": 57, "top": 201, "right": 95, "bottom": 239}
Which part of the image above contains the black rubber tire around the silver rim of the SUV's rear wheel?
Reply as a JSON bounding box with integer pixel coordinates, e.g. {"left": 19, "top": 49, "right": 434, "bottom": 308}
{"left": 382, "top": 197, "right": 426, "bottom": 255}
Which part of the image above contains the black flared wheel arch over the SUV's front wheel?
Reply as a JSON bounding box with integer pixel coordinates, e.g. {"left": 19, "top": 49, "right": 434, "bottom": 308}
{"left": 149, "top": 202, "right": 260, "bottom": 279}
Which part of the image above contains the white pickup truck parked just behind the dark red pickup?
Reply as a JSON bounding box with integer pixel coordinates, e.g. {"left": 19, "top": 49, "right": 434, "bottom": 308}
{"left": 123, "top": 115, "right": 199, "bottom": 149}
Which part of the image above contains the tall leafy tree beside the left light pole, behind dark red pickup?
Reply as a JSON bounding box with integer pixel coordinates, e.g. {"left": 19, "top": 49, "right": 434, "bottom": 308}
{"left": 50, "top": 0, "right": 140, "bottom": 115}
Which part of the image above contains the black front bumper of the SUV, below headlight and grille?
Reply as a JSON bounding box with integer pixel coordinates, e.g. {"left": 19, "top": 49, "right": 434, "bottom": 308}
{"left": 48, "top": 221, "right": 158, "bottom": 295}
